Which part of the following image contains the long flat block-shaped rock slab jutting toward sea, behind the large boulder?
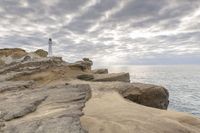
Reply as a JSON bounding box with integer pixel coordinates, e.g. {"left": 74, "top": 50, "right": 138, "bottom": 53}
{"left": 93, "top": 73, "right": 130, "bottom": 82}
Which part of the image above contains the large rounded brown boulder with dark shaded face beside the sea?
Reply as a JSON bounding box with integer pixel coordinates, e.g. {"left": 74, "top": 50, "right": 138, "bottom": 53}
{"left": 119, "top": 83, "right": 169, "bottom": 109}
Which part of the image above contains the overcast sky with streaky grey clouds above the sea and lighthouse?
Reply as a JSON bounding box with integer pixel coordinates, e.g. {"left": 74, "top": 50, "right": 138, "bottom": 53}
{"left": 0, "top": 0, "right": 200, "bottom": 65}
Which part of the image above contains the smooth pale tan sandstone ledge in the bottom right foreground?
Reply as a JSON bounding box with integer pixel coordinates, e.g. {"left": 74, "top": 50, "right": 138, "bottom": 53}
{"left": 81, "top": 91, "right": 200, "bottom": 133}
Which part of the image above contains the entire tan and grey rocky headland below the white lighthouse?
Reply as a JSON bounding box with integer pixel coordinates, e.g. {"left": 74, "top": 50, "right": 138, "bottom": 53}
{"left": 0, "top": 49, "right": 200, "bottom": 133}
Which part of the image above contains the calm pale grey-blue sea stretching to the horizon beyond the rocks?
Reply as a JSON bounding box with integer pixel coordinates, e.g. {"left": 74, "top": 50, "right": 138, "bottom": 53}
{"left": 98, "top": 65, "right": 200, "bottom": 116}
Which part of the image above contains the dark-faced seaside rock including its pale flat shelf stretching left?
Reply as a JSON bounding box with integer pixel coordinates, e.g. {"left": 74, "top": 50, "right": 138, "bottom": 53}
{"left": 87, "top": 82, "right": 169, "bottom": 109}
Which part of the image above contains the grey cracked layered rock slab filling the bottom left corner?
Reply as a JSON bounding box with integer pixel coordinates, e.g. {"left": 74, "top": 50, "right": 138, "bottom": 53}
{"left": 0, "top": 85, "right": 90, "bottom": 133}
